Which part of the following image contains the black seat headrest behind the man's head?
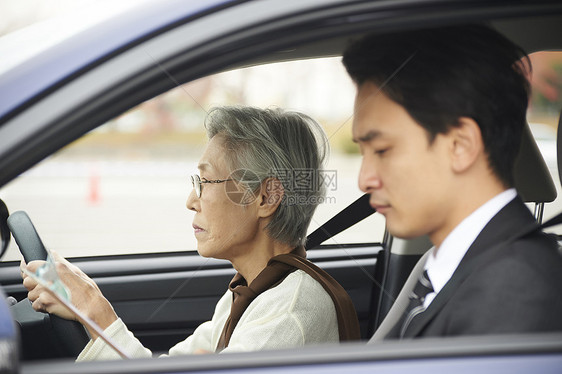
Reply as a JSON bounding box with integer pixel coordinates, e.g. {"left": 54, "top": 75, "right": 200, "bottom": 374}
{"left": 513, "top": 124, "right": 561, "bottom": 203}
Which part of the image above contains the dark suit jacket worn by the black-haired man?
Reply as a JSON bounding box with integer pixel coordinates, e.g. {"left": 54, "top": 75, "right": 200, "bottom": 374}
{"left": 385, "top": 197, "right": 562, "bottom": 338}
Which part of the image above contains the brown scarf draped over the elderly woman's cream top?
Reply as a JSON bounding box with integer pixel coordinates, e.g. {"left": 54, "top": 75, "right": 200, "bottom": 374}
{"left": 216, "top": 247, "right": 360, "bottom": 352}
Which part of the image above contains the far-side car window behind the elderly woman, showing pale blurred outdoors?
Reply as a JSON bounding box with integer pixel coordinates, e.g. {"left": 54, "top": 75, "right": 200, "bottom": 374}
{"left": 0, "top": 58, "right": 384, "bottom": 260}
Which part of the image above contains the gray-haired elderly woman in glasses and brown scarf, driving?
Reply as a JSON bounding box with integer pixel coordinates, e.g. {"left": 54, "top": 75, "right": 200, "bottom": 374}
{"left": 24, "top": 107, "right": 359, "bottom": 361}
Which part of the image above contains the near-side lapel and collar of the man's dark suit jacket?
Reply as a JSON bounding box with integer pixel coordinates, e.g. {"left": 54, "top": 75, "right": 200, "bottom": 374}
{"left": 405, "top": 197, "right": 538, "bottom": 338}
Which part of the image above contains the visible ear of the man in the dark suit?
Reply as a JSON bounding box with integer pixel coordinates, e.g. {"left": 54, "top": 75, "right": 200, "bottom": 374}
{"left": 447, "top": 117, "right": 484, "bottom": 173}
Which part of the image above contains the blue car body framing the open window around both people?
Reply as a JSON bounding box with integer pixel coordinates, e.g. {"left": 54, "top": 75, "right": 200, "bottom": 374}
{"left": 0, "top": 0, "right": 562, "bottom": 374}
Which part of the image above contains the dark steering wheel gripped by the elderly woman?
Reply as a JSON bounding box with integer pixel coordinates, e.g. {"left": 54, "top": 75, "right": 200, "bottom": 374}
{"left": 8, "top": 211, "right": 90, "bottom": 359}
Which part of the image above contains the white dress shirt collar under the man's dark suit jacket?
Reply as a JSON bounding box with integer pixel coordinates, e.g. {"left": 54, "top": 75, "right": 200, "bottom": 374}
{"left": 424, "top": 188, "right": 517, "bottom": 308}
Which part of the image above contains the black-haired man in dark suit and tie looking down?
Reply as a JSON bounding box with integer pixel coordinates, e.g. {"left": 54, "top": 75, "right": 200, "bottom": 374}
{"left": 343, "top": 26, "right": 562, "bottom": 339}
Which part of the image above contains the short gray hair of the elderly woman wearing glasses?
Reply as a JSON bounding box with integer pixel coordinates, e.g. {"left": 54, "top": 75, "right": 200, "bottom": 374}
{"left": 205, "top": 106, "right": 328, "bottom": 247}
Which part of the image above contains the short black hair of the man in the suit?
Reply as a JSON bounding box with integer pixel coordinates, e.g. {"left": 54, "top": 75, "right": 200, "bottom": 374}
{"left": 343, "top": 25, "right": 530, "bottom": 186}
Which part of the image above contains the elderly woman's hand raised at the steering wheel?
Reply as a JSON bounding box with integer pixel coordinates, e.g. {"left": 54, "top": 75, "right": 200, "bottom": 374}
{"left": 20, "top": 252, "right": 117, "bottom": 339}
